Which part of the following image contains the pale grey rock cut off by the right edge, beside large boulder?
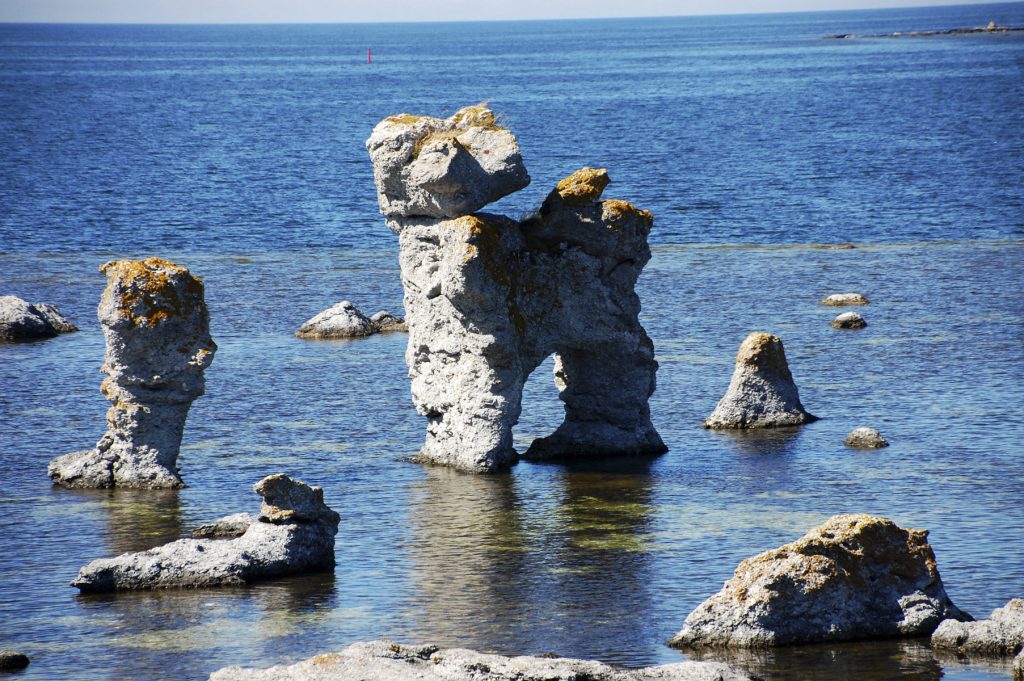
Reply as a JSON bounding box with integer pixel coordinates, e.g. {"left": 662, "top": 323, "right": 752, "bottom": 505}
{"left": 932, "top": 598, "right": 1024, "bottom": 657}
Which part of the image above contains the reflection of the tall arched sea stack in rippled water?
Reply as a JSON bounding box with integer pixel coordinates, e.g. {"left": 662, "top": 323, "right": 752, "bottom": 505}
{"left": 409, "top": 459, "right": 660, "bottom": 663}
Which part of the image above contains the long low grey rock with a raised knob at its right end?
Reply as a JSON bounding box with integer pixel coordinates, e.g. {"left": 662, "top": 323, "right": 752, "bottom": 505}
{"left": 71, "top": 475, "right": 339, "bottom": 593}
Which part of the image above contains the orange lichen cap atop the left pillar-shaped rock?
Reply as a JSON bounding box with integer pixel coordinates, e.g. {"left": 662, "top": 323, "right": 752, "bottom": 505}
{"left": 99, "top": 258, "right": 203, "bottom": 328}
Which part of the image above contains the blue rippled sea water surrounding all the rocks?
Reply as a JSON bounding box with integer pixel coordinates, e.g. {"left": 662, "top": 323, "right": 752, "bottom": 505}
{"left": 0, "top": 3, "right": 1024, "bottom": 680}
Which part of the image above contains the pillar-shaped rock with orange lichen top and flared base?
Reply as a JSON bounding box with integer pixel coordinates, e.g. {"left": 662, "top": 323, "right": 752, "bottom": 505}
{"left": 48, "top": 258, "right": 217, "bottom": 488}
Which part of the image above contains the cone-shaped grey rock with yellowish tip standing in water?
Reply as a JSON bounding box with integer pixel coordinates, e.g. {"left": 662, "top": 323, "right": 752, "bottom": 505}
{"left": 703, "top": 333, "right": 817, "bottom": 430}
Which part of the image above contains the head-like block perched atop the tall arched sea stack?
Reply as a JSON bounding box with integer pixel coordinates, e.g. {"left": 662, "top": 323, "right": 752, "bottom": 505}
{"left": 367, "top": 105, "right": 529, "bottom": 218}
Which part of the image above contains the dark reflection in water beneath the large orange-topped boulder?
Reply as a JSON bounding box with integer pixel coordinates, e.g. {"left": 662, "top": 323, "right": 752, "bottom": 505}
{"left": 686, "top": 640, "right": 942, "bottom": 681}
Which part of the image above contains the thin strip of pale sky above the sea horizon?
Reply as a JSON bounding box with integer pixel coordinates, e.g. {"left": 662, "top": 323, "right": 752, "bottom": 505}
{"left": 0, "top": 0, "right": 1003, "bottom": 24}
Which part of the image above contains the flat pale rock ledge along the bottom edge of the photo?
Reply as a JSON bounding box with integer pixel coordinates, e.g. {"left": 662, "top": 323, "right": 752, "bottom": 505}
{"left": 210, "top": 640, "right": 751, "bottom": 681}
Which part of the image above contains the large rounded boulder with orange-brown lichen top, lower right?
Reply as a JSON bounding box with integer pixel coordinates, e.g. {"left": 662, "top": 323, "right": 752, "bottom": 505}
{"left": 670, "top": 515, "right": 970, "bottom": 647}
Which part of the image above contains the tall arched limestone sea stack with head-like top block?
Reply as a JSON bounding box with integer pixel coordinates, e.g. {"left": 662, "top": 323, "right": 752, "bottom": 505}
{"left": 367, "top": 107, "right": 666, "bottom": 472}
